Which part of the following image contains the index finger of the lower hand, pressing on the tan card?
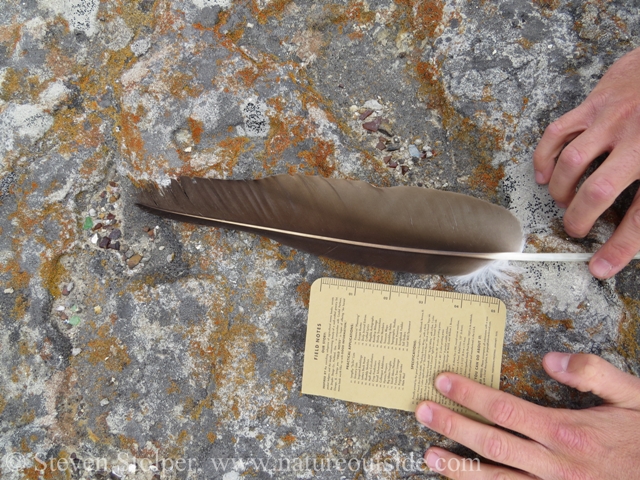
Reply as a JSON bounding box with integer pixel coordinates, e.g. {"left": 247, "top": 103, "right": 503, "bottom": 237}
{"left": 435, "top": 373, "right": 555, "bottom": 445}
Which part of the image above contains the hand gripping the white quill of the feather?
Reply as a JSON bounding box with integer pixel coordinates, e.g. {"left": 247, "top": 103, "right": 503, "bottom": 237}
{"left": 533, "top": 49, "right": 640, "bottom": 278}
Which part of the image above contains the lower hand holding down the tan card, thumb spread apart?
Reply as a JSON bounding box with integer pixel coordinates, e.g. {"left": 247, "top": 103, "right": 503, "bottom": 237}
{"left": 416, "top": 352, "right": 640, "bottom": 480}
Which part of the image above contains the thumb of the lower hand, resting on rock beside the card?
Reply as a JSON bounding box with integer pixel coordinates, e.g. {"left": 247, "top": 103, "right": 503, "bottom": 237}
{"left": 542, "top": 352, "right": 640, "bottom": 409}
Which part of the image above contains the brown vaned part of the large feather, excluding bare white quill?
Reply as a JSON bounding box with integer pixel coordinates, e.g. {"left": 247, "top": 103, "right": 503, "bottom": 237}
{"left": 137, "top": 175, "right": 523, "bottom": 275}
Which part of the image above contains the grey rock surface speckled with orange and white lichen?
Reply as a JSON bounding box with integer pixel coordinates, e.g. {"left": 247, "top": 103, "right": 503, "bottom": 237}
{"left": 0, "top": 0, "right": 640, "bottom": 480}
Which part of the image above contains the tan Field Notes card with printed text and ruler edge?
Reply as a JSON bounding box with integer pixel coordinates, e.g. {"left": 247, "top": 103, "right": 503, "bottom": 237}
{"left": 302, "top": 278, "right": 506, "bottom": 416}
